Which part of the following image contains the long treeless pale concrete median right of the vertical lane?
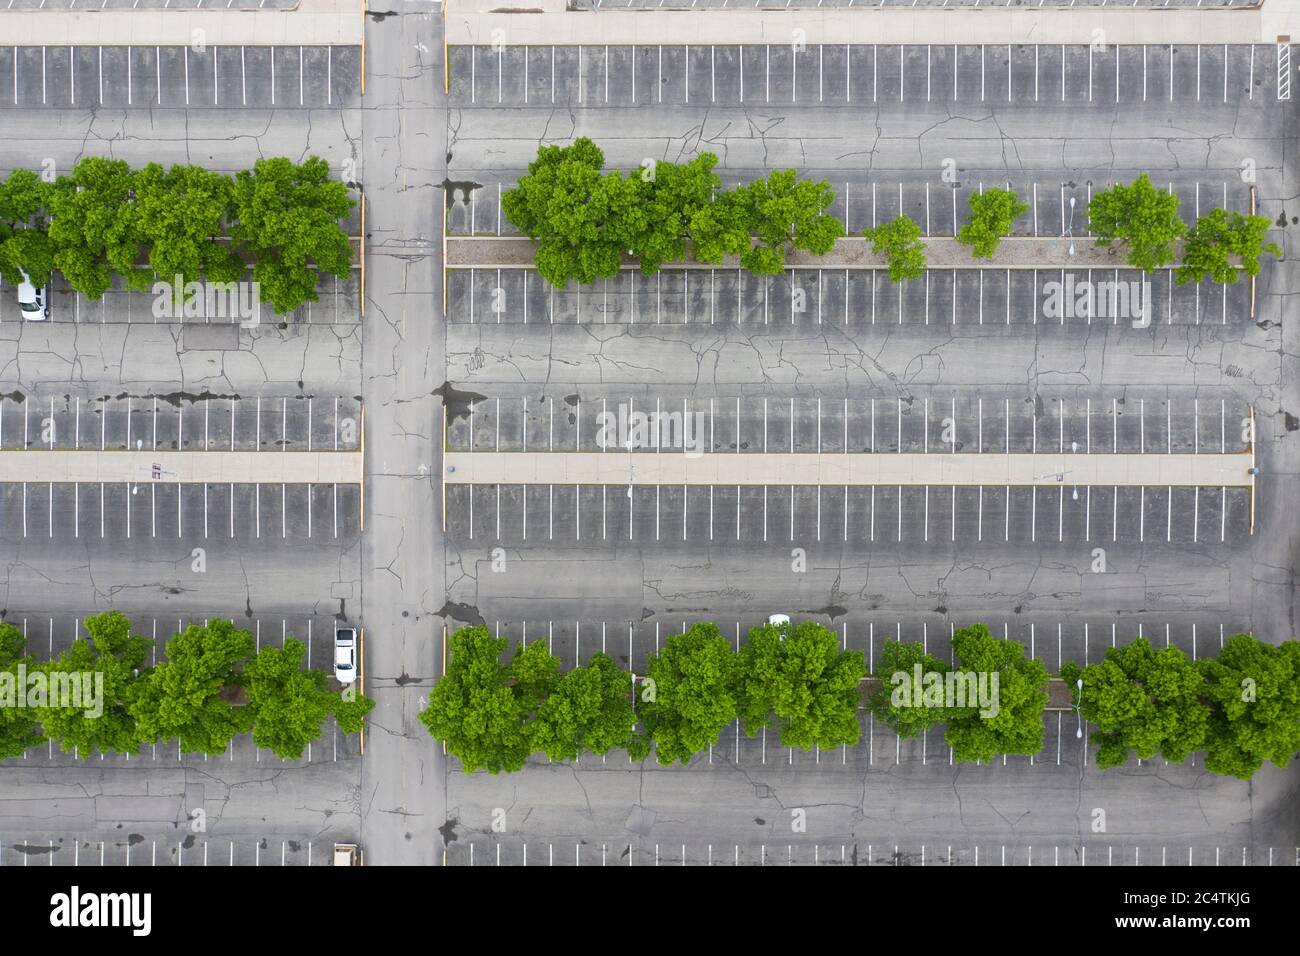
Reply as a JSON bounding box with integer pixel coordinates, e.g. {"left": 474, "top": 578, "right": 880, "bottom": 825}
{"left": 443, "top": 450, "right": 1255, "bottom": 488}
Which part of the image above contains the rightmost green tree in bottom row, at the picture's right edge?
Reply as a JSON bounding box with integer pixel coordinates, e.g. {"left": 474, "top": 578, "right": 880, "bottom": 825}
{"left": 1197, "top": 633, "right": 1300, "bottom": 780}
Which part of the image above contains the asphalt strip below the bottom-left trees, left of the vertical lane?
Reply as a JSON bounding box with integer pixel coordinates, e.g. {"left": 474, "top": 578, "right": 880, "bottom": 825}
{"left": 0, "top": 749, "right": 360, "bottom": 868}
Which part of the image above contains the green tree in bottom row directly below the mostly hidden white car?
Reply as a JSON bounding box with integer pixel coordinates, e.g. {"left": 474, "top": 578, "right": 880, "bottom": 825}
{"left": 737, "top": 620, "right": 867, "bottom": 750}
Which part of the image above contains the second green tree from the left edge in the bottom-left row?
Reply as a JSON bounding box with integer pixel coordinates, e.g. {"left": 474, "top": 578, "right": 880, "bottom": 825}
{"left": 35, "top": 611, "right": 152, "bottom": 758}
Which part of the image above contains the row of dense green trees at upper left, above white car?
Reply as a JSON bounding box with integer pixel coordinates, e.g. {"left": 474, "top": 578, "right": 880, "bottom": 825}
{"left": 0, "top": 156, "right": 356, "bottom": 312}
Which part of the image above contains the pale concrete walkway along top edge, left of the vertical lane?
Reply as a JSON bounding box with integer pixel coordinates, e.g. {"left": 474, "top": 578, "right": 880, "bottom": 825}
{"left": 0, "top": 0, "right": 365, "bottom": 46}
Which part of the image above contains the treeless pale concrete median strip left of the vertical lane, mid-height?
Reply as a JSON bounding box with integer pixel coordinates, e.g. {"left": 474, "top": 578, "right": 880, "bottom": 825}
{"left": 0, "top": 449, "right": 361, "bottom": 485}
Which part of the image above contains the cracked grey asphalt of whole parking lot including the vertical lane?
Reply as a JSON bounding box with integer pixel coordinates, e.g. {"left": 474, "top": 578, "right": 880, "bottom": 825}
{"left": 0, "top": 26, "right": 1300, "bottom": 865}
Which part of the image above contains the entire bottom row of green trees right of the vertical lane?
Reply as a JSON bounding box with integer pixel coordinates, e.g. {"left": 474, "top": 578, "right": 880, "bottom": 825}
{"left": 420, "top": 622, "right": 1300, "bottom": 779}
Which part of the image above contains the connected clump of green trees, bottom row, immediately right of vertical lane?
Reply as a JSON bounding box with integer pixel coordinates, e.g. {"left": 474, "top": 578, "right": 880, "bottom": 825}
{"left": 420, "top": 622, "right": 867, "bottom": 773}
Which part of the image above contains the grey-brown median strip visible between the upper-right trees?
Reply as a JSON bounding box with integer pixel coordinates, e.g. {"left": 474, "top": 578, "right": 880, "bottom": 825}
{"left": 447, "top": 235, "right": 1180, "bottom": 269}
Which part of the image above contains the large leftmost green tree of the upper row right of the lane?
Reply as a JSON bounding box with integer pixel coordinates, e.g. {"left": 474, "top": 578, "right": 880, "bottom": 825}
{"left": 502, "top": 137, "right": 642, "bottom": 286}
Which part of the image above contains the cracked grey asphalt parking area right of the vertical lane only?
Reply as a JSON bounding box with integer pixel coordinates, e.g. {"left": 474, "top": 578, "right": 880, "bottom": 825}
{"left": 431, "top": 37, "right": 1300, "bottom": 865}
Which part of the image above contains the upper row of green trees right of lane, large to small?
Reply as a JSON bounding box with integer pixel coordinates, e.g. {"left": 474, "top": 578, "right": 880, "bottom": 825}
{"left": 502, "top": 137, "right": 1282, "bottom": 286}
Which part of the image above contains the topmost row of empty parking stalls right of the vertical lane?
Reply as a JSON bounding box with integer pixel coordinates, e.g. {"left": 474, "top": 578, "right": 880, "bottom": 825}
{"left": 450, "top": 43, "right": 1278, "bottom": 109}
